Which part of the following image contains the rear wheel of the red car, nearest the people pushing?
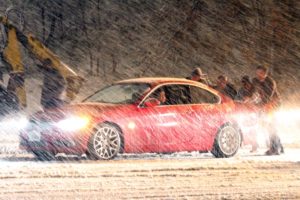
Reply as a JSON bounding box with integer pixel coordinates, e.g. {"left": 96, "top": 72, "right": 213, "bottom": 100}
{"left": 211, "top": 124, "right": 241, "bottom": 158}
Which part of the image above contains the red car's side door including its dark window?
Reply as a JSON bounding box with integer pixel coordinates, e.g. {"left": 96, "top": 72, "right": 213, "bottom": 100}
{"left": 141, "top": 84, "right": 197, "bottom": 152}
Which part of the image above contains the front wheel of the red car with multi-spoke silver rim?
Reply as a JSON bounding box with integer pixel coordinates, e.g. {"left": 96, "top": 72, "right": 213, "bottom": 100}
{"left": 87, "top": 123, "right": 122, "bottom": 160}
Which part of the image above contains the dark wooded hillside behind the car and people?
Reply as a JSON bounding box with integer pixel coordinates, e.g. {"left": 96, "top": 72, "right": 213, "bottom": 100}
{"left": 0, "top": 0, "right": 300, "bottom": 104}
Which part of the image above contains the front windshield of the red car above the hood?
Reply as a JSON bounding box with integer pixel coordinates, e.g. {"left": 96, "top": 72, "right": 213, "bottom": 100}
{"left": 84, "top": 83, "right": 150, "bottom": 104}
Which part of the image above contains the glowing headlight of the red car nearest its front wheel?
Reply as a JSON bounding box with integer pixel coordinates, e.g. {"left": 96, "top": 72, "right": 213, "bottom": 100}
{"left": 56, "top": 117, "right": 90, "bottom": 131}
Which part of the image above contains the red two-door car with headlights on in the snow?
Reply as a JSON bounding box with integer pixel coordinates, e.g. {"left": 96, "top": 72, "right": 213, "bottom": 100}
{"left": 20, "top": 78, "right": 242, "bottom": 160}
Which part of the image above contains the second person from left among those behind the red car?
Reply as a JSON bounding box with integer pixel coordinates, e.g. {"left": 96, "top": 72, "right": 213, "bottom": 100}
{"left": 214, "top": 75, "right": 237, "bottom": 99}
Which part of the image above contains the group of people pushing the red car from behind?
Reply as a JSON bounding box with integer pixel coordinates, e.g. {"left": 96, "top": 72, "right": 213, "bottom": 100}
{"left": 187, "top": 66, "right": 284, "bottom": 155}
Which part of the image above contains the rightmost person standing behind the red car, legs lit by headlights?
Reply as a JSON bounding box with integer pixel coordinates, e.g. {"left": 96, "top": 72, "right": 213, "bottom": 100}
{"left": 253, "top": 66, "right": 284, "bottom": 155}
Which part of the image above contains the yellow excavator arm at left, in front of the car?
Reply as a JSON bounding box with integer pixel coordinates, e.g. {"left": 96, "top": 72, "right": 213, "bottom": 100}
{"left": 0, "top": 16, "right": 84, "bottom": 107}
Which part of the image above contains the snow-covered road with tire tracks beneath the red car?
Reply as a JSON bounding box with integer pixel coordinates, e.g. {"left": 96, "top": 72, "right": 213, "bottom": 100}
{"left": 0, "top": 149, "right": 300, "bottom": 199}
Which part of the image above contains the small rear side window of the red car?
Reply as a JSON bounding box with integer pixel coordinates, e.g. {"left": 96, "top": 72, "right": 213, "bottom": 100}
{"left": 189, "top": 86, "right": 219, "bottom": 104}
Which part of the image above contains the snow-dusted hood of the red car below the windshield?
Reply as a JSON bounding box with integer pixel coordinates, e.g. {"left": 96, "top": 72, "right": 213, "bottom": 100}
{"left": 31, "top": 103, "right": 128, "bottom": 122}
